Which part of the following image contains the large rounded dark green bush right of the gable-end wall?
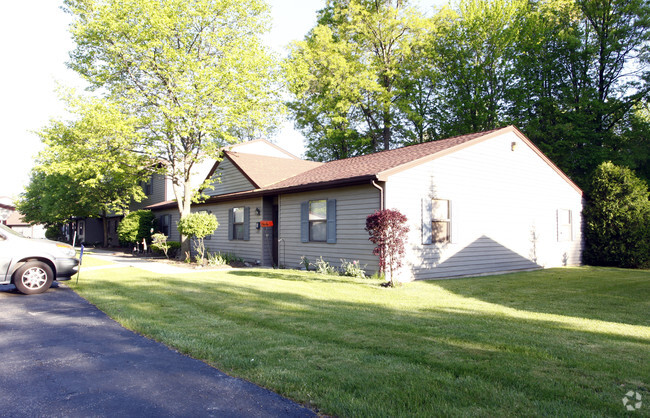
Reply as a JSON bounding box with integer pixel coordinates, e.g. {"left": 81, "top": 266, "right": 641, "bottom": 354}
{"left": 583, "top": 162, "right": 650, "bottom": 268}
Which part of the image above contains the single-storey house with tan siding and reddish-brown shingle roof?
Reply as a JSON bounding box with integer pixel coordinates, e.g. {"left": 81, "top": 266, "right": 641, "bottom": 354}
{"left": 148, "top": 126, "right": 583, "bottom": 280}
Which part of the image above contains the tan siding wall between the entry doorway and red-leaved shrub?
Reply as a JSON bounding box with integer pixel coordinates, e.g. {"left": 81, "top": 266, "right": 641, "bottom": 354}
{"left": 278, "top": 185, "right": 379, "bottom": 273}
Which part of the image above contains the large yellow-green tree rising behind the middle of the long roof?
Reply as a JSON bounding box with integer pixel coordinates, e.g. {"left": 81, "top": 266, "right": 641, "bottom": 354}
{"left": 285, "top": 0, "right": 424, "bottom": 161}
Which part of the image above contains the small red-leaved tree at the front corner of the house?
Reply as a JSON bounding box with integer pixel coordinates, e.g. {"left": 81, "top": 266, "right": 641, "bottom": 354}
{"left": 366, "top": 209, "right": 409, "bottom": 287}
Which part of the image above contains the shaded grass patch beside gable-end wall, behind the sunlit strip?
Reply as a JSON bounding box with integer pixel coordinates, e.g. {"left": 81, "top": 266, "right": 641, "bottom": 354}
{"left": 418, "top": 267, "right": 650, "bottom": 326}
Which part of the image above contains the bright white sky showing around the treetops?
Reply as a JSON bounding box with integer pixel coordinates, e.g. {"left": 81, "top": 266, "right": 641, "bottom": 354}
{"left": 0, "top": 0, "right": 440, "bottom": 199}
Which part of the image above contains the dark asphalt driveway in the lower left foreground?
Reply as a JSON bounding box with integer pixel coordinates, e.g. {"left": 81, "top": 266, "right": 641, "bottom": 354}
{"left": 0, "top": 286, "right": 315, "bottom": 417}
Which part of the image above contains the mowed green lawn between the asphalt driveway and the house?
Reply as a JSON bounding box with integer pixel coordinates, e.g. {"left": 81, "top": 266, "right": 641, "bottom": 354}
{"left": 72, "top": 267, "right": 650, "bottom": 416}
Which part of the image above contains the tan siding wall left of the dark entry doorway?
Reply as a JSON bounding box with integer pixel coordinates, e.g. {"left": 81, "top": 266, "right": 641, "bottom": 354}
{"left": 200, "top": 198, "right": 265, "bottom": 263}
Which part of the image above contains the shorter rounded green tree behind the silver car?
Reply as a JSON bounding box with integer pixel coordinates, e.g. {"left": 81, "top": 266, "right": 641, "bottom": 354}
{"left": 32, "top": 95, "right": 155, "bottom": 245}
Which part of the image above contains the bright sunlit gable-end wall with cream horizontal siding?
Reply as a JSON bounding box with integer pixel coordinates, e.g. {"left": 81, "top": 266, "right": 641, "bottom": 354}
{"left": 386, "top": 133, "right": 582, "bottom": 280}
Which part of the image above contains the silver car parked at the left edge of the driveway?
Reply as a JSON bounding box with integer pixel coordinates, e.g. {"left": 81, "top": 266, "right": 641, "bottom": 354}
{"left": 0, "top": 225, "right": 79, "bottom": 295}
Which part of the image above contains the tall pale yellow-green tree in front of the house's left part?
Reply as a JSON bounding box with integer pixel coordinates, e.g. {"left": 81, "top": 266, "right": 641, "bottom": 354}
{"left": 65, "top": 0, "right": 278, "bottom": 255}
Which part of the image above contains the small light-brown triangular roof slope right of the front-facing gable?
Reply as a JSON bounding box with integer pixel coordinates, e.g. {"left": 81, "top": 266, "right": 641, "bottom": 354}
{"left": 224, "top": 151, "right": 324, "bottom": 188}
